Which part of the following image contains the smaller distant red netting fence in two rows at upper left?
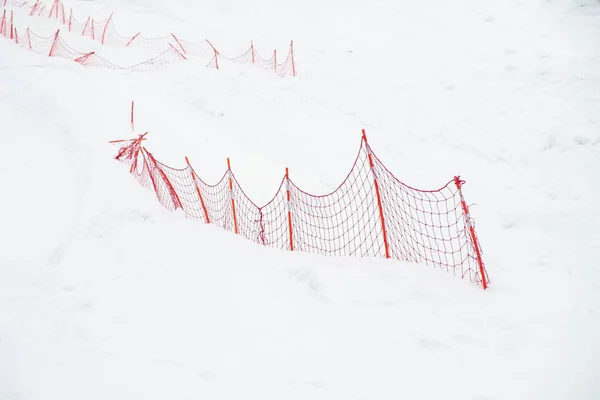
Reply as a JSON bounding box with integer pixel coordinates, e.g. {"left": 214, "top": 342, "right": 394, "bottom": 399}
{"left": 0, "top": 0, "right": 296, "bottom": 76}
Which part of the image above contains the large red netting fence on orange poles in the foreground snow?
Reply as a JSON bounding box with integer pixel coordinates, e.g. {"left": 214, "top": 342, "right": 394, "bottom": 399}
{"left": 115, "top": 104, "right": 489, "bottom": 289}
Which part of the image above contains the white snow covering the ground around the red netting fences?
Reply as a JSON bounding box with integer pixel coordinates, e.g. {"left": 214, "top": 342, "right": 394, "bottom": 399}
{"left": 0, "top": 0, "right": 600, "bottom": 400}
